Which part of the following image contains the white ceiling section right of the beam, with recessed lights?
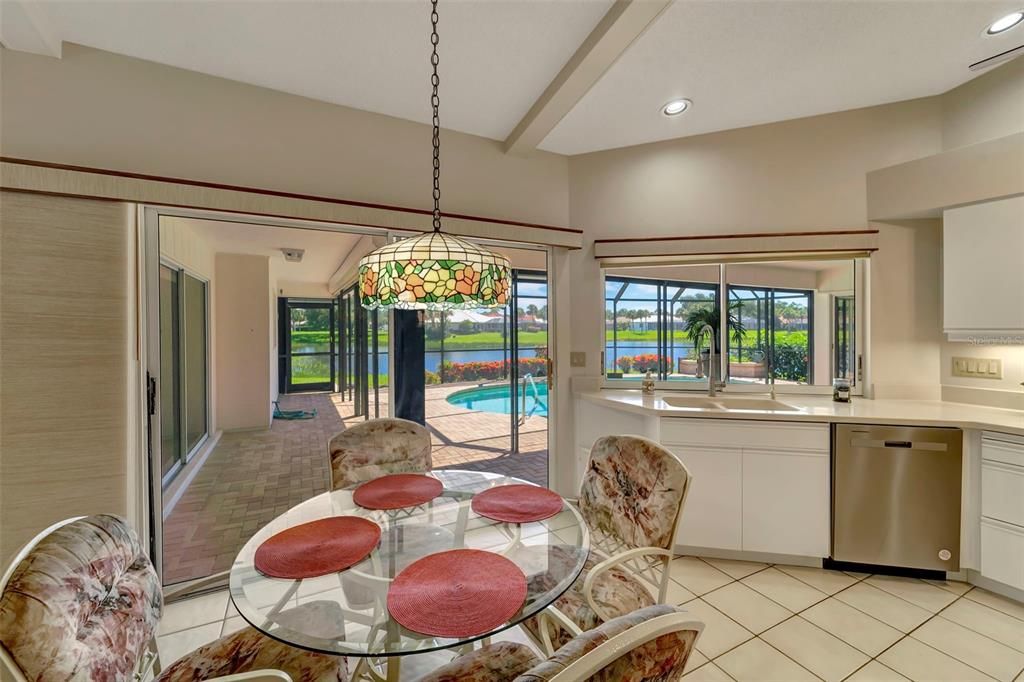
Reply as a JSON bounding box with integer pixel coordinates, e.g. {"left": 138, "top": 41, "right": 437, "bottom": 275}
{"left": 541, "top": 0, "right": 1024, "bottom": 154}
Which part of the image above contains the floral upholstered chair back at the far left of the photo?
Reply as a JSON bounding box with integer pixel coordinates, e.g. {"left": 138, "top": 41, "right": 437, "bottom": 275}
{"left": 0, "top": 514, "right": 164, "bottom": 680}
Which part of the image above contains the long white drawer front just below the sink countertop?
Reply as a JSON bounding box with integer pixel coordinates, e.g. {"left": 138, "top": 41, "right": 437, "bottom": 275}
{"left": 662, "top": 417, "right": 828, "bottom": 453}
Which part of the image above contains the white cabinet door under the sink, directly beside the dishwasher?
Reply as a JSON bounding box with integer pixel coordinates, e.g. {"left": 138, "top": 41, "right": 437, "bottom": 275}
{"left": 742, "top": 449, "right": 831, "bottom": 557}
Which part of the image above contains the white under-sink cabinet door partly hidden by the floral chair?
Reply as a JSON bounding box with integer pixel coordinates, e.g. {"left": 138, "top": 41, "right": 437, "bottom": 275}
{"left": 668, "top": 445, "right": 742, "bottom": 550}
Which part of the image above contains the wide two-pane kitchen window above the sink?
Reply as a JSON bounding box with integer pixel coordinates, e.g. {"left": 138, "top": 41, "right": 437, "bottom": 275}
{"left": 603, "top": 259, "right": 863, "bottom": 392}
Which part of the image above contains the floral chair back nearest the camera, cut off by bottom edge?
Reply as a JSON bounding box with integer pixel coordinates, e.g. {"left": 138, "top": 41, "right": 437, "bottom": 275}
{"left": 515, "top": 604, "right": 703, "bottom": 682}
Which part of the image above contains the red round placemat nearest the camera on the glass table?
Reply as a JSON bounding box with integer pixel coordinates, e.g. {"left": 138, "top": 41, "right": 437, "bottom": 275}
{"left": 387, "top": 549, "right": 526, "bottom": 637}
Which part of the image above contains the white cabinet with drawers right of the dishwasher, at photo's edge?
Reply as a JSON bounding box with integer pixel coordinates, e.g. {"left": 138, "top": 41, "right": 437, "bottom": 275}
{"left": 981, "top": 432, "right": 1024, "bottom": 590}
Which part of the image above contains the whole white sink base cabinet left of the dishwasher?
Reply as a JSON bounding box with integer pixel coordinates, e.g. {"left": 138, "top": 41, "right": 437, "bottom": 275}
{"left": 660, "top": 418, "right": 831, "bottom": 557}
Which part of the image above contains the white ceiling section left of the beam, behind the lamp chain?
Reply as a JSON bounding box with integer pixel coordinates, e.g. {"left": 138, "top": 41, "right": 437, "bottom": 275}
{"left": 29, "top": 0, "right": 611, "bottom": 139}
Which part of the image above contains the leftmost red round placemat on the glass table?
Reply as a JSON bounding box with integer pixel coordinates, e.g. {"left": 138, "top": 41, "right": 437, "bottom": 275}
{"left": 253, "top": 516, "right": 381, "bottom": 580}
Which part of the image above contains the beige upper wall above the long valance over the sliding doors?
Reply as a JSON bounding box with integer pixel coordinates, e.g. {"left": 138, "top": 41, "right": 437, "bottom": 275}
{"left": 0, "top": 43, "right": 568, "bottom": 226}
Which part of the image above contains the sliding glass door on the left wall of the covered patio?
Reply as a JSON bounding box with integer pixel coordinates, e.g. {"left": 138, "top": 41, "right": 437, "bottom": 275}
{"left": 160, "top": 264, "right": 209, "bottom": 485}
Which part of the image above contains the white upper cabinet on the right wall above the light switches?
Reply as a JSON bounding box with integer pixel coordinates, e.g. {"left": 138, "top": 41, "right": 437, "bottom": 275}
{"left": 942, "top": 197, "right": 1024, "bottom": 343}
